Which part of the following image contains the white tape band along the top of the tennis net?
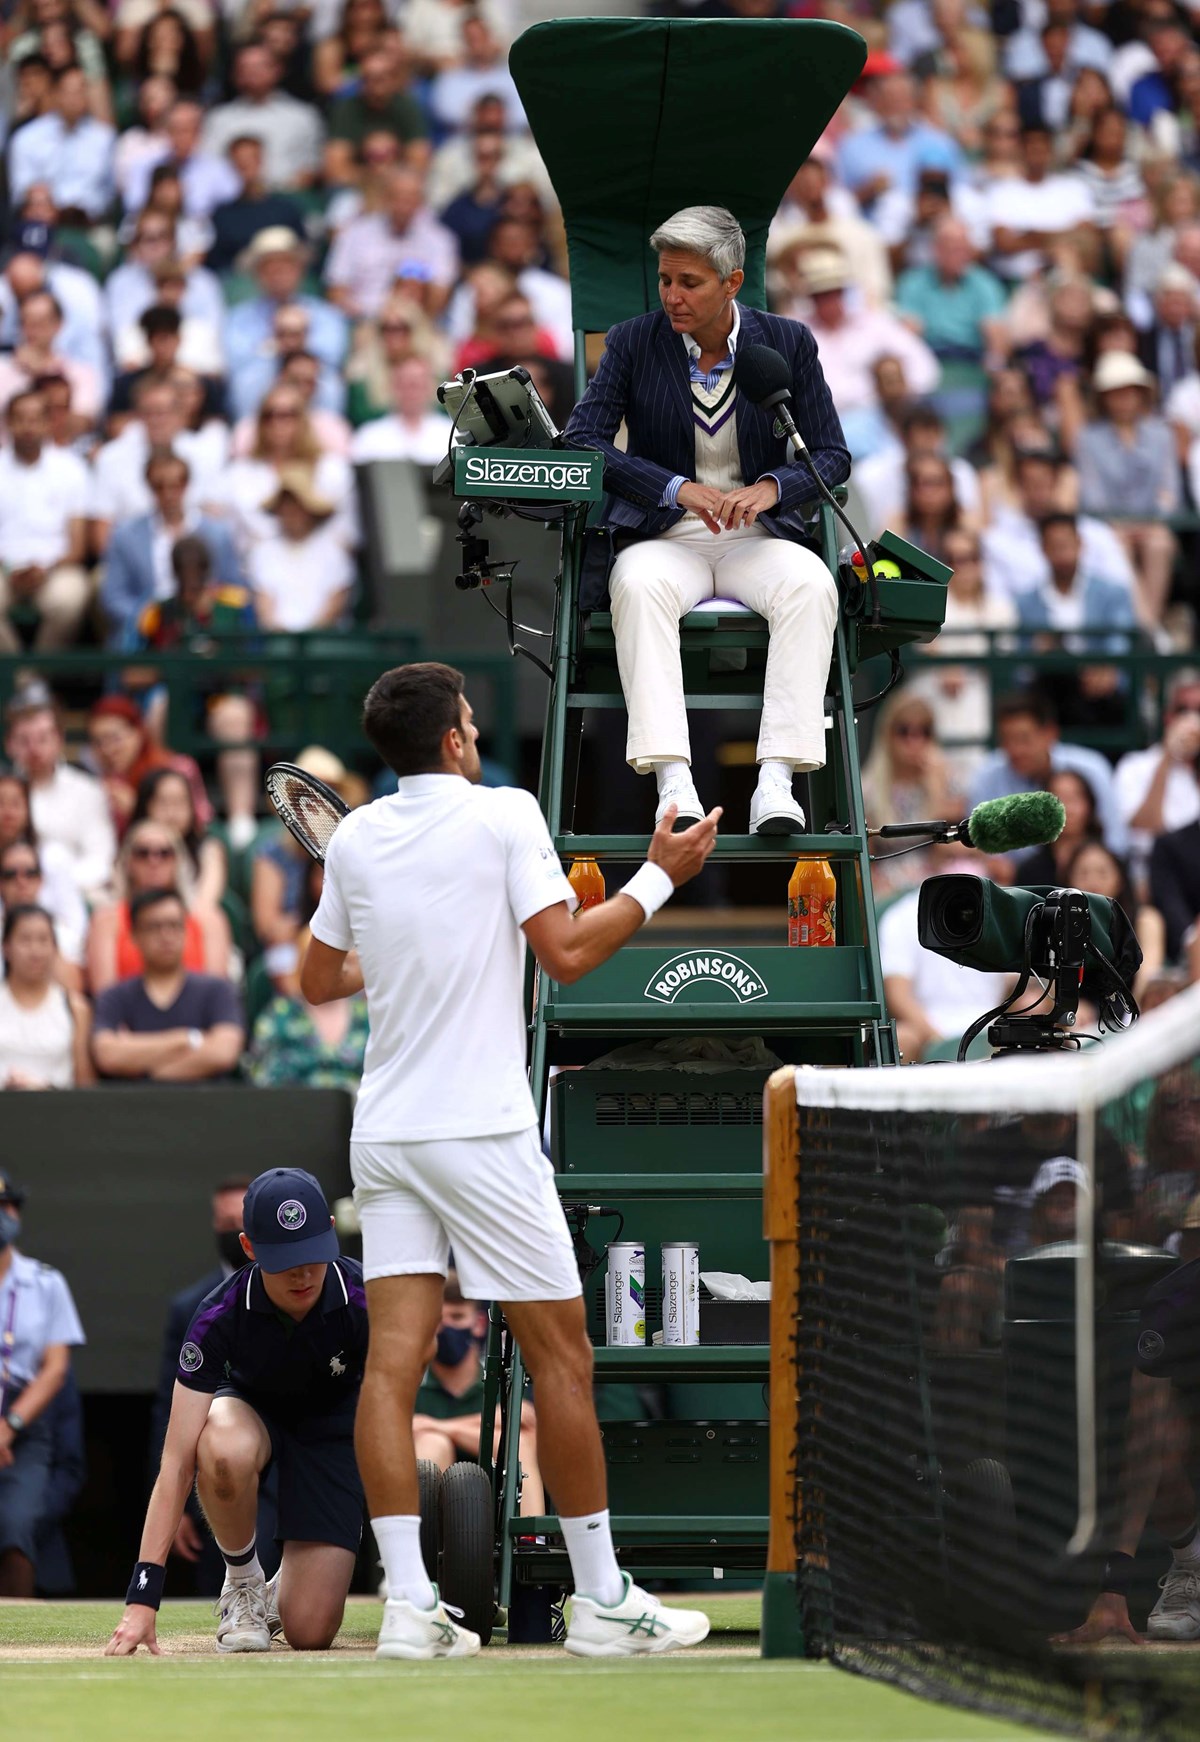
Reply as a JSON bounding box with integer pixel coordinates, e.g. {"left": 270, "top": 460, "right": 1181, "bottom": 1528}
{"left": 796, "top": 986, "right": 1200, "bottom": 1113}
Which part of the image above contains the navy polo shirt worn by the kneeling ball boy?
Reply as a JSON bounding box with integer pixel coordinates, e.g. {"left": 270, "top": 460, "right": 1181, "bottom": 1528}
{"left": 176, "top": 1258, "right": 367, "bottom": 1420}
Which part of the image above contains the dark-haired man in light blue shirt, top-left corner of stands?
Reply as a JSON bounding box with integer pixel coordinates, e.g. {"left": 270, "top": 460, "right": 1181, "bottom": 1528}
{"left": 9, "top": 64, "right": 117, "bottom": 228}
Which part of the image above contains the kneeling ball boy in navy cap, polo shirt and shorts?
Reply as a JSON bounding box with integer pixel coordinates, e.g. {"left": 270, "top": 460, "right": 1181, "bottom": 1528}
{"left": 104, "top": 1167, "right": 367, "bottom": 1657}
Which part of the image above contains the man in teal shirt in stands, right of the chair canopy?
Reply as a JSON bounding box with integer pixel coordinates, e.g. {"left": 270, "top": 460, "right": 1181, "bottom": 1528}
{"left": 895, "top": 216, "right": 1008, "bottom": 362}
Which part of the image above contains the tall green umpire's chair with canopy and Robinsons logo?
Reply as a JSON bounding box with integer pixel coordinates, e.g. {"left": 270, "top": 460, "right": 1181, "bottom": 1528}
{"left": 448, "top": 19, "right": 946, "bottom": 1637}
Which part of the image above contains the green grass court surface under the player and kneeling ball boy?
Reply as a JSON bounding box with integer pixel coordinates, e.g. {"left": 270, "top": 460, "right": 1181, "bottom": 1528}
{"left": 0, "top": 1596, "right": 1058, "bottom": 1742}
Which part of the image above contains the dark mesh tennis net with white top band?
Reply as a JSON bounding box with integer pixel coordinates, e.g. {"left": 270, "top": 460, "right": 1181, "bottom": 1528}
{"left": 768, "top": 988, "right": 1200, "bottom": 1742}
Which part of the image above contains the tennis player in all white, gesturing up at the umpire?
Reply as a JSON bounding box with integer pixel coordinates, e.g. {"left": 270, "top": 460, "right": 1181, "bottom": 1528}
{"left": 301, "top": 664, "right": 721, "bottom": 1658}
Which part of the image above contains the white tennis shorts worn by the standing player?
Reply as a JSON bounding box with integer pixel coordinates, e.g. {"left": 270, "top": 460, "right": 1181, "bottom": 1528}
{"left": 350, "top": 1125, "right": 583, "bottom": 1301}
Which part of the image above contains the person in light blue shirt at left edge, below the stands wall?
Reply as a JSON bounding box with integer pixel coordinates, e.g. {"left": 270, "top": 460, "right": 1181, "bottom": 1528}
{"left": 0, "top": 1172, "right": 85, "bottom": 1597}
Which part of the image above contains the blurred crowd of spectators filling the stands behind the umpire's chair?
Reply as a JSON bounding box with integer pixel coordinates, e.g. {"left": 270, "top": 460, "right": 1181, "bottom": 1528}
{"left": 0, "top": 0, "right": 1200, "bottom": 1087}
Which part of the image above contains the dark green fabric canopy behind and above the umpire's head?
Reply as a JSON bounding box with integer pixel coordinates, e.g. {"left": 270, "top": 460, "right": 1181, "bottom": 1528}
{"left": 509, "top": 17, "right": 867, "bottom": 333}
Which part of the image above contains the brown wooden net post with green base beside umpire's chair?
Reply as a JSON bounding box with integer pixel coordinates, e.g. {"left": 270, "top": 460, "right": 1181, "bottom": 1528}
{"left": 761, "top": 1064, "right": 805, "bottom": 1657}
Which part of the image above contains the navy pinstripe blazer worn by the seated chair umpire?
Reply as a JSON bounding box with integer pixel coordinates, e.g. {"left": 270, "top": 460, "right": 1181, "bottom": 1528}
{"left": 566, "top": 308, "right": 850, "bottom": 540}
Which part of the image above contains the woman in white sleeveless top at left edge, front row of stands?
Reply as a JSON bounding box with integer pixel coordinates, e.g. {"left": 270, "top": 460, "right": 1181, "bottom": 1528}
{"left": 0, "top": 912, "right": 96, "bottom": 1090}
